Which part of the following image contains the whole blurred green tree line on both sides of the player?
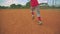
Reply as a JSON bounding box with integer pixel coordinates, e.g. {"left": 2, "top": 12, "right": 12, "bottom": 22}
{"left": 0, "top": 2, "right": 60, "bottom": 9}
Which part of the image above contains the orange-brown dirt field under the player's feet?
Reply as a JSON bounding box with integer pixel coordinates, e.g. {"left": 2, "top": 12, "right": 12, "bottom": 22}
{"left": 0, "top": 9, "right": 60, "bottom": 34}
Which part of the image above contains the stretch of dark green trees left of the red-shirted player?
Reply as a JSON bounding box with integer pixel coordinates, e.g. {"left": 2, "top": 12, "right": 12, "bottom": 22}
{"left": 0, "top": 2, "right": 30, "bottom": 9}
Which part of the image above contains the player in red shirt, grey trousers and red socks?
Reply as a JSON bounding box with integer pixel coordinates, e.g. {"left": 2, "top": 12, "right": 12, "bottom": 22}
{"left": 30, "top": 0, "right": 42, "bottom": 24}
